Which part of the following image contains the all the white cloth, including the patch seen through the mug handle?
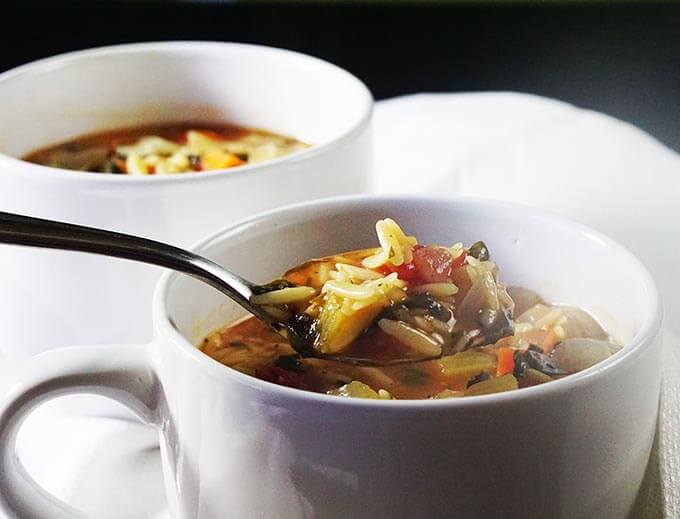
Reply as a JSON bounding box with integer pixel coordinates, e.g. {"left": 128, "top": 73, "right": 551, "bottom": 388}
{"left": 10, "top": 93, "right": 680, "bottom": 519}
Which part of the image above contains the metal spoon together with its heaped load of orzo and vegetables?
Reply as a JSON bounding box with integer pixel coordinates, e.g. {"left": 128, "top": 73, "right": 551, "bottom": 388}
{"left": 0, "top": 213, "right": 500, "bottom": 366}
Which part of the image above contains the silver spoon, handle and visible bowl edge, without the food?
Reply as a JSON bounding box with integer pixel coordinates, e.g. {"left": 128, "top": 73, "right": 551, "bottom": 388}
{"left": 0, "top": 212, "right": 430, "bottom": 366}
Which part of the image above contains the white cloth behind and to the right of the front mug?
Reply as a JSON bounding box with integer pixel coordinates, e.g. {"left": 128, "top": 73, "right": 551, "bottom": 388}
{"left": 374, "top": 93, "right": 680, "bottom": 519}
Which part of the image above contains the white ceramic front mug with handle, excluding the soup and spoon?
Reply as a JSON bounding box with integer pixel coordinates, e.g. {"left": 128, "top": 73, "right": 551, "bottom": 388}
{"left": 0, "top": 197, "right": 662, "bottom": 519}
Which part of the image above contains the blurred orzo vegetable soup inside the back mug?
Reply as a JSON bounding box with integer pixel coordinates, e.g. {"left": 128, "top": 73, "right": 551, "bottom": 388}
{"left": 23, "top": 122, "right": 309, "bottom": 175}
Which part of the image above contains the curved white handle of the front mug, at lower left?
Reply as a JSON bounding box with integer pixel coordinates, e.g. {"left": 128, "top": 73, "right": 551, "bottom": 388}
{"left": 0, "top": 345, "right": 160, "bottom": 519}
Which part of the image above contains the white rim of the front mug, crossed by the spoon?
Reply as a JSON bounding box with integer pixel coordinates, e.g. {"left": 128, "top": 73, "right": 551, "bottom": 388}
{"left": 152, "top": 195, "right": 663, "bottom": 411}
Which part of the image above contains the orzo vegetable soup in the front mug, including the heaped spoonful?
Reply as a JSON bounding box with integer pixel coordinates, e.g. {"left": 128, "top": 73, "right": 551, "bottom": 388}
{"left": 201, "top": 219, "right": 620, "bottom": 399}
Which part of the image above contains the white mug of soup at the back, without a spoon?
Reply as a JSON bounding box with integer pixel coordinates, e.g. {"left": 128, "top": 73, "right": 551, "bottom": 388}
{"left": 0, "top": 42, "right": 372, "bottom": 356}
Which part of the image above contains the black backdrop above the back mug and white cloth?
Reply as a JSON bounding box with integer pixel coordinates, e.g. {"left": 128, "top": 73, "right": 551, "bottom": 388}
{"left": 5, "top": 0, "right": 680, "bottom": 150}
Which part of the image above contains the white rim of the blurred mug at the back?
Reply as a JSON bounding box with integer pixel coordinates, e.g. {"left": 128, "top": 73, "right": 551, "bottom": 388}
{"left": 0, "top": 40, "right": 374, "bottom": 184}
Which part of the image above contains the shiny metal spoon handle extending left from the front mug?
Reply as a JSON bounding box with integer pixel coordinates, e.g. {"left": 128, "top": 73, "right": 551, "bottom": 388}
{"left": 0, "top": 212, "right": 262, "bottom": 315}
